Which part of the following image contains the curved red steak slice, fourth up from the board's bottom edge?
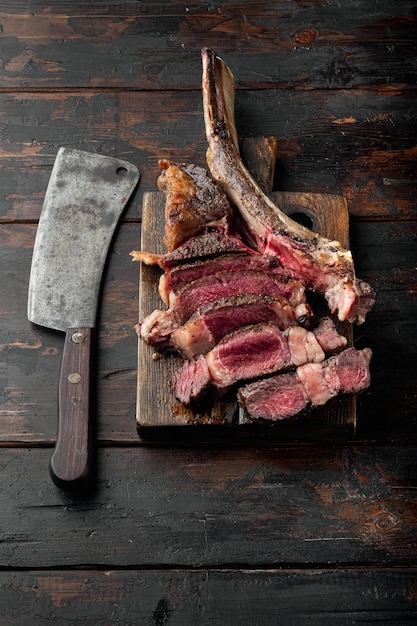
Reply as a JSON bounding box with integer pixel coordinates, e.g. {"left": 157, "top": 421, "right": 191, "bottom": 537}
{"left": 169, "top": 270, "right": 310, "bottom": 324}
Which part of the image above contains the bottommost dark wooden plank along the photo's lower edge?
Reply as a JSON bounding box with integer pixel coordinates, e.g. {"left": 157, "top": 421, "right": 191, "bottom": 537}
{"left": 0, "top": 569, "right": 417, "bottom": 626}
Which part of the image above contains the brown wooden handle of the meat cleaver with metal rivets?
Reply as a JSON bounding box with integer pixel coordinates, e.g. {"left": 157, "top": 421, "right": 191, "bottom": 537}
{"left": 49, "top": 327, "right": 94, "bottom": 490}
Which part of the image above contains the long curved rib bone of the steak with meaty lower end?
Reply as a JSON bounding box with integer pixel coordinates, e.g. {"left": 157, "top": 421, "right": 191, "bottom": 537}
{"left": 202, "top": 48, "right": 375, "bottom": 324}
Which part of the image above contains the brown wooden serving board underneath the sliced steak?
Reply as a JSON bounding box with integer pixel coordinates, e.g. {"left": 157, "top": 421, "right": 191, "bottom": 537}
{"left": 136, "top": 138, "right": 356, "bottom": 441}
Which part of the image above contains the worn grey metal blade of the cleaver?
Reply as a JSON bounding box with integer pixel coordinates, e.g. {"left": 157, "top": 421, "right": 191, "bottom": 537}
{"left": 28, "top": 148, "right": 140, "bottom": 331}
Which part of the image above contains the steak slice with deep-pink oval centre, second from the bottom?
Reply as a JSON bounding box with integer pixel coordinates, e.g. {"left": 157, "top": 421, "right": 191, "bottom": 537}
{"left": 174, "top": 323, "right": 348, "bottom": 404}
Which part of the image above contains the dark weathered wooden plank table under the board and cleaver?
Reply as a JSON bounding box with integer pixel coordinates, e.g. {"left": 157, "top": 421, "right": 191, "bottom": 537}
{"left": 0, "top": 0, "right": 417, "bottom": 626}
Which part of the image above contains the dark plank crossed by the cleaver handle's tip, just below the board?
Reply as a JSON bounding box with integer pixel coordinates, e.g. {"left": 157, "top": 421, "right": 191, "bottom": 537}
{"left": 0, "top": 442, "right": 417, "bottom": 570}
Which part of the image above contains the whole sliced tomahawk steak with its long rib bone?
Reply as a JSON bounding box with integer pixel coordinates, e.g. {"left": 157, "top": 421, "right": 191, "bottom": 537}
{"left": 136, "top": 49, "right": 375, "bottom": 421}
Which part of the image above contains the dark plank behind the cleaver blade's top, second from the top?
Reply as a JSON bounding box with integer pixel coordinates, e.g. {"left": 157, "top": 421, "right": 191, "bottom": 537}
{"left": 0, "top": 88, "right": 417, "bottom": 221}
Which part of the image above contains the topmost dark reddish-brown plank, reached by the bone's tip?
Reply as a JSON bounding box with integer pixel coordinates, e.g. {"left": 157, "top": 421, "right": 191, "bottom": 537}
{"left": 0, "top": 0, "right": 415, "bottom": 90}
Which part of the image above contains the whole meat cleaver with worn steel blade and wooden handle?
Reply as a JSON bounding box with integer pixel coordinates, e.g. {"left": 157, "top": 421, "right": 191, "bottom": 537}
{"left": 28, "top": 148, "right": 140, "bottom": 489}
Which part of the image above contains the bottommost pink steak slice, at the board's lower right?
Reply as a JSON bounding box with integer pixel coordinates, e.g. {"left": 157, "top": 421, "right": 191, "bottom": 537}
{"left": 238, "top": 348, "right": 372, "bottom": 421}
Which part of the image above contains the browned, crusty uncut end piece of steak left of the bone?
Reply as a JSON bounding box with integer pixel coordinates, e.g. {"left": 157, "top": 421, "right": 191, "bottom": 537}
{"left": 157, "top": 159, "right": 232, "bottom": 251}
